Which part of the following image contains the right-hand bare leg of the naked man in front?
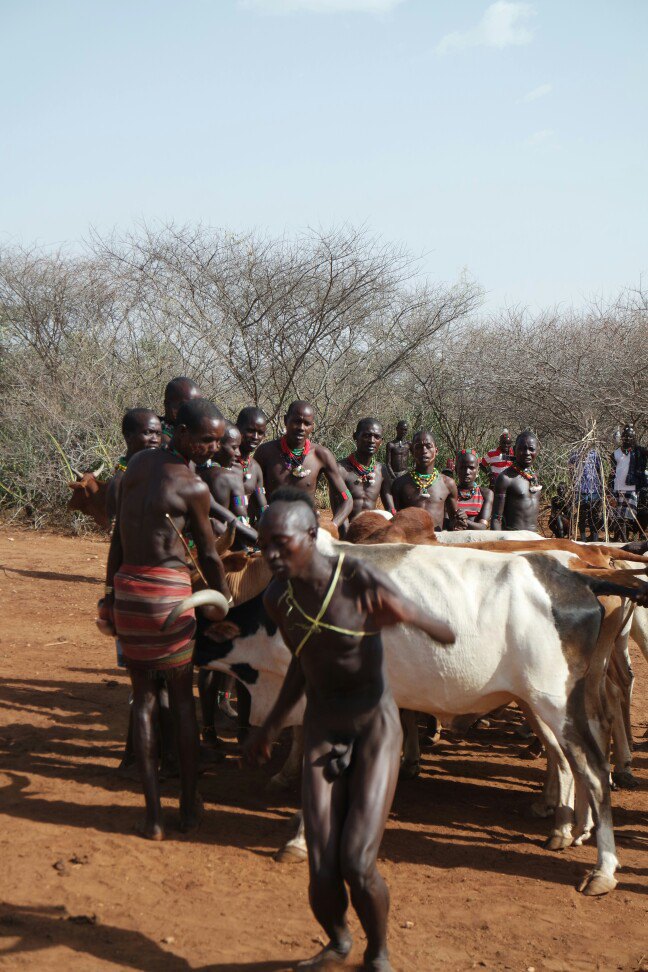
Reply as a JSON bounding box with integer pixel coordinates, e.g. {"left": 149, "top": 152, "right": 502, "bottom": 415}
{"left": 340, "top": 699, "right": 402, "bottom": 972}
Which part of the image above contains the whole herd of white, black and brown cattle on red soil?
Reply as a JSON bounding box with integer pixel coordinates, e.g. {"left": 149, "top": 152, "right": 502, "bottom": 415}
{"left": 73, "top": 473, "right": 648, "bottom": 895}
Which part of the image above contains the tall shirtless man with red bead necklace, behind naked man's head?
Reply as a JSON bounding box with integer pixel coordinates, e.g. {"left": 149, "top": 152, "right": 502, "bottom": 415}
{"left": 255, "top": 401, "right": 353, "bottom": 528}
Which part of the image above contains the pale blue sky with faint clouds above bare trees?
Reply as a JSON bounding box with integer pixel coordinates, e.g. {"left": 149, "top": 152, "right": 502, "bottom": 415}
{"left": 0, "top": 0, "right": 648, "bottom": 308}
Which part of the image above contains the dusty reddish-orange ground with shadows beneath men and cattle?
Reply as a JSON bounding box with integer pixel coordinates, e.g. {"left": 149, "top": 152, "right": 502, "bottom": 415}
{"left": 0, "top": 527, "right": 648, "bottom": 972}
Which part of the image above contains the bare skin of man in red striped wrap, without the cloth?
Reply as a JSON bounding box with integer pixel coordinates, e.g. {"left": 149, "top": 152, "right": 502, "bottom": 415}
{"left": 100, "top": 417, "right": 230, "bottom": 840}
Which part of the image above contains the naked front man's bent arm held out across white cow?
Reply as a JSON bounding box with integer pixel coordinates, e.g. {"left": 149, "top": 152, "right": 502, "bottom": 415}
{"left": 349, "top": 560, "right": 455, "bottom": 645}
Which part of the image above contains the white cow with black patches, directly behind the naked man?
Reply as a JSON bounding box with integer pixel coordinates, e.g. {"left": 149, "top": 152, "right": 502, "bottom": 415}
{"left": 177, "top": 533, "right": 648, "bottom": 894}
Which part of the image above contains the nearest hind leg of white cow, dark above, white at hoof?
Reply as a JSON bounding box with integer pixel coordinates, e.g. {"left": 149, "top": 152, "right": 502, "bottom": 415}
{"left": 534, "top": 697, "right": 619, "bottom": 895}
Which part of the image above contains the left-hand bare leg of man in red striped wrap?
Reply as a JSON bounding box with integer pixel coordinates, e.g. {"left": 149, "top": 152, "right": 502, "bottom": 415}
{"left": 130, "top": 669, "right": 164, "bottom": 840}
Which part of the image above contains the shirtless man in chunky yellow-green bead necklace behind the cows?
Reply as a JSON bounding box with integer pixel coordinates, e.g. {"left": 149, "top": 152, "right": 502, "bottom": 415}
{"left": 392, "top": 430, "right": 468, "bottom": 530}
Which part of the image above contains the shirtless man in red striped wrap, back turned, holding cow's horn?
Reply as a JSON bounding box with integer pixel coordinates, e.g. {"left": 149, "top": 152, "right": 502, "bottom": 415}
{"left": 99, "top": 399, "right": 230, "bottom": 840}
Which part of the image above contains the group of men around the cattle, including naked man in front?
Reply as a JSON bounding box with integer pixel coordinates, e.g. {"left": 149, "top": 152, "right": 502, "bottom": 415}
{"left": 99, "top": 378, "right": 552, "bottom": 972}
